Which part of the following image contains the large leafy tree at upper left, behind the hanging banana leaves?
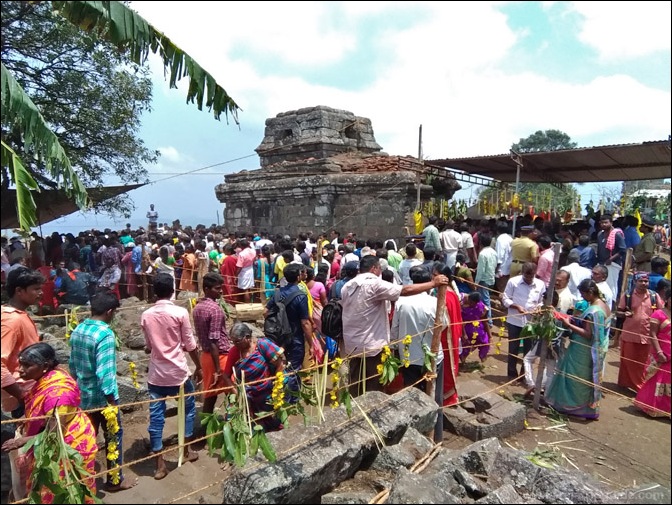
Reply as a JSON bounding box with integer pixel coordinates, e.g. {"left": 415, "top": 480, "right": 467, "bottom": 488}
{"left": 1, "top": 1, "right": 158, "bottom": 216}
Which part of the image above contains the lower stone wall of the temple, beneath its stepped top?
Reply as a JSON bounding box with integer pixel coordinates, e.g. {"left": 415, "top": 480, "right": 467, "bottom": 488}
{"left": 216, "top": 172, "right": 431, "bottom": 238}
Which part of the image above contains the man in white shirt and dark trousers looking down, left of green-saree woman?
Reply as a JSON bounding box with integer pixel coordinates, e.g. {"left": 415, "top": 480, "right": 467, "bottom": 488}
{"left": 502, "top": 261, "right": 546, "bottom": 379}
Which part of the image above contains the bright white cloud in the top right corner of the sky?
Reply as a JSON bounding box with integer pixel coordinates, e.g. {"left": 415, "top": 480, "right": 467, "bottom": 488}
{"left": 573, "top": 2, "right": 672, "bottom": 61}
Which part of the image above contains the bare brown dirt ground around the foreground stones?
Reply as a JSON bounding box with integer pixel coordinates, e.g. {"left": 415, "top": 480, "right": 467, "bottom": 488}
{"left": 100, "top": 349, "right": 671, "bottom": 504}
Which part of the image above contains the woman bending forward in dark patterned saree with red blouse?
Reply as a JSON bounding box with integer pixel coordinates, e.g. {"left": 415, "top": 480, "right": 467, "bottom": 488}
{"left": 223, "top": 323, "right": 285, "bottom": 431}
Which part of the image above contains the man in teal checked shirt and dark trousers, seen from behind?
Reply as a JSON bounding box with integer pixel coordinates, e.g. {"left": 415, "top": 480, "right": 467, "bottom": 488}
{"left": 69, "top": 290, "right": 137, "bottom": 492}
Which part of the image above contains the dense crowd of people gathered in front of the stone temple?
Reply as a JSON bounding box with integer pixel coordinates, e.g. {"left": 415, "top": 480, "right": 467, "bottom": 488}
{"left": 2, "top": 214, "right": 670, "bottom": 503}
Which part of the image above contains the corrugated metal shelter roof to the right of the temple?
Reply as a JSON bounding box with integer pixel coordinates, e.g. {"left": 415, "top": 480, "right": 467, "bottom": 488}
{"left": 425, "top": 140, "right": 671, "bottom": 183}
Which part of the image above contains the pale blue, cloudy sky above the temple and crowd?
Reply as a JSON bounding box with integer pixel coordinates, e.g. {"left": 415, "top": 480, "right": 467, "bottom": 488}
{"left": 15, "top": 1, "right": 672, "bottom": 234}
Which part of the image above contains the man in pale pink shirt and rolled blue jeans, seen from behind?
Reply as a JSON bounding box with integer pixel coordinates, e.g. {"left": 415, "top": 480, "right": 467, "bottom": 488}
{"left": 140, "top": 274, "right": 202, "bottom": 480}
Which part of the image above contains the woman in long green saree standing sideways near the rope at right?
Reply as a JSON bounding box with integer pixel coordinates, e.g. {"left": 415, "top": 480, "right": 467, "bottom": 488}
{"left": 545, "top": 279, "right": 609, "bottom": 419}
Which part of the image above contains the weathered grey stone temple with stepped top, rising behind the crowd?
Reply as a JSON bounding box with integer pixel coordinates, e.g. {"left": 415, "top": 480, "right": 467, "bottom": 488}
{"left": 215, "top": 106, "right": 460, "bottom": 238}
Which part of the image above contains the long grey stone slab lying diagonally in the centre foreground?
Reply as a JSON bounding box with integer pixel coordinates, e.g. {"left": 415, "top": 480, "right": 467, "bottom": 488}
{"left": 222, "top": 388, "right": 438, "bottom": 503}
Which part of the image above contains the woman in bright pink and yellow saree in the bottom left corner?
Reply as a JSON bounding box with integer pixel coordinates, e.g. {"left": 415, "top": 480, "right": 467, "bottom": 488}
{"left": 2, "top": 342, "right": 98, "bottom": 503}
